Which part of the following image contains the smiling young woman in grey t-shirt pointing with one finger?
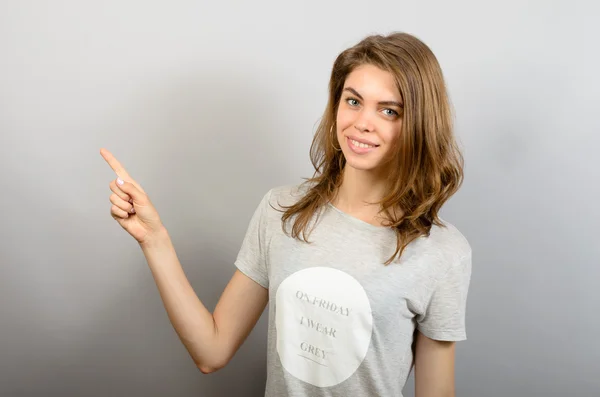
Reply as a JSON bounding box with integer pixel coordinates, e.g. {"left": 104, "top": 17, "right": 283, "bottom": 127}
{"left": 101, "top": 33, "right": 471, "bottom": 397}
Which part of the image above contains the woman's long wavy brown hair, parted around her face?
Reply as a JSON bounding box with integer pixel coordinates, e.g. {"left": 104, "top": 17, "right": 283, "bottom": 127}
{"left": 282, "top": 33, "right": 463, "bottom": 264}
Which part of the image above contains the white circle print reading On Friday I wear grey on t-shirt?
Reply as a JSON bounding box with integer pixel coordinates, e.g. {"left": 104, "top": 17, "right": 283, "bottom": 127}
{"left": 275, "top": 267, "right": 373, "bottom": 387}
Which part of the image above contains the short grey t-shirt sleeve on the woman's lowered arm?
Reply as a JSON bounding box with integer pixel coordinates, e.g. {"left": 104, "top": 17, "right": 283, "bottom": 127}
{"left": 417, "top": 252, "right": 471, "bottom": 341}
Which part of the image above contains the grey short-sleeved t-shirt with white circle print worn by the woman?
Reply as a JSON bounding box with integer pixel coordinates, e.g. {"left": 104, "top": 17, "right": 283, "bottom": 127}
{"left": 235, "top": 186, "right": 471, "bottom": 397}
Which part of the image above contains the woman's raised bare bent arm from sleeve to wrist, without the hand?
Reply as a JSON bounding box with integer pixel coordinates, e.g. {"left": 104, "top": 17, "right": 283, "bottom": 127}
{"left": 142, "top": 230, "right": 268, "bottom": 373}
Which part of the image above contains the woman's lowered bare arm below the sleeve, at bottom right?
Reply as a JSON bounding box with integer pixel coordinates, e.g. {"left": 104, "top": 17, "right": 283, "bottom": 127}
{"left": 415, "top": 331, "right": 456, "bottom": 397}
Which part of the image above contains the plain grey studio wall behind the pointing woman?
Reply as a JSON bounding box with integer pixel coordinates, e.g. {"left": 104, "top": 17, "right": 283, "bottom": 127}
{"left": 0, "top": 0, "right": 600, "bottom": 397}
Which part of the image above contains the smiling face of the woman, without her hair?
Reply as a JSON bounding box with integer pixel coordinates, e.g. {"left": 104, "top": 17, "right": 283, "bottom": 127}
{"left": 336, "top": 64, "right": 402, "bottom": 171}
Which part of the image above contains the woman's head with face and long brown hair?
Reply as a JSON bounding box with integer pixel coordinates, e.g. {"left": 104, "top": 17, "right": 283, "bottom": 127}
{"left": 284, "top": 33, "right": 463, "bottom": 262}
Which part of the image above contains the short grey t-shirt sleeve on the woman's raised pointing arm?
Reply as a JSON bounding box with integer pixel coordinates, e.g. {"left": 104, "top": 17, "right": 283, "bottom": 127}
{"left": 235, "top": 191, "right": 271, "bottom": 288}
